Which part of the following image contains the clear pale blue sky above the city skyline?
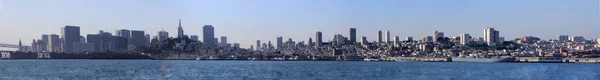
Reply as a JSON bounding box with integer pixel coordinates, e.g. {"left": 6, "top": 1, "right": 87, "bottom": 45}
{"left": 0, "top": 0, "right": 600, "bottom": 47}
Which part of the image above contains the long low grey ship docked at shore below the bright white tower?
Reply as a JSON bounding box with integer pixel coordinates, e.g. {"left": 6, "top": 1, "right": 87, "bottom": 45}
{"left": 451, "top": 57, "right": 517, "bottom": 62}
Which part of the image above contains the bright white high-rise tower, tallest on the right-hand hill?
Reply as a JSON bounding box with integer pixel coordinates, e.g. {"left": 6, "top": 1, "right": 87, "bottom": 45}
{"left": 483, "top": 27, "right": 500, "bottom": 46}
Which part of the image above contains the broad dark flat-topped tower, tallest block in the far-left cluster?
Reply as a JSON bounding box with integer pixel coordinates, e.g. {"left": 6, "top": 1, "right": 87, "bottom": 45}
{"left": 61, "top": 26, "right": 81, "bottom": 53}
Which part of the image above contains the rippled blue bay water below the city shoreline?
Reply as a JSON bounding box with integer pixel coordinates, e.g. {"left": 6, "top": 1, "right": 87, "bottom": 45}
{"left": 0, "top": 60, "right": 600, "bottom": 80}
